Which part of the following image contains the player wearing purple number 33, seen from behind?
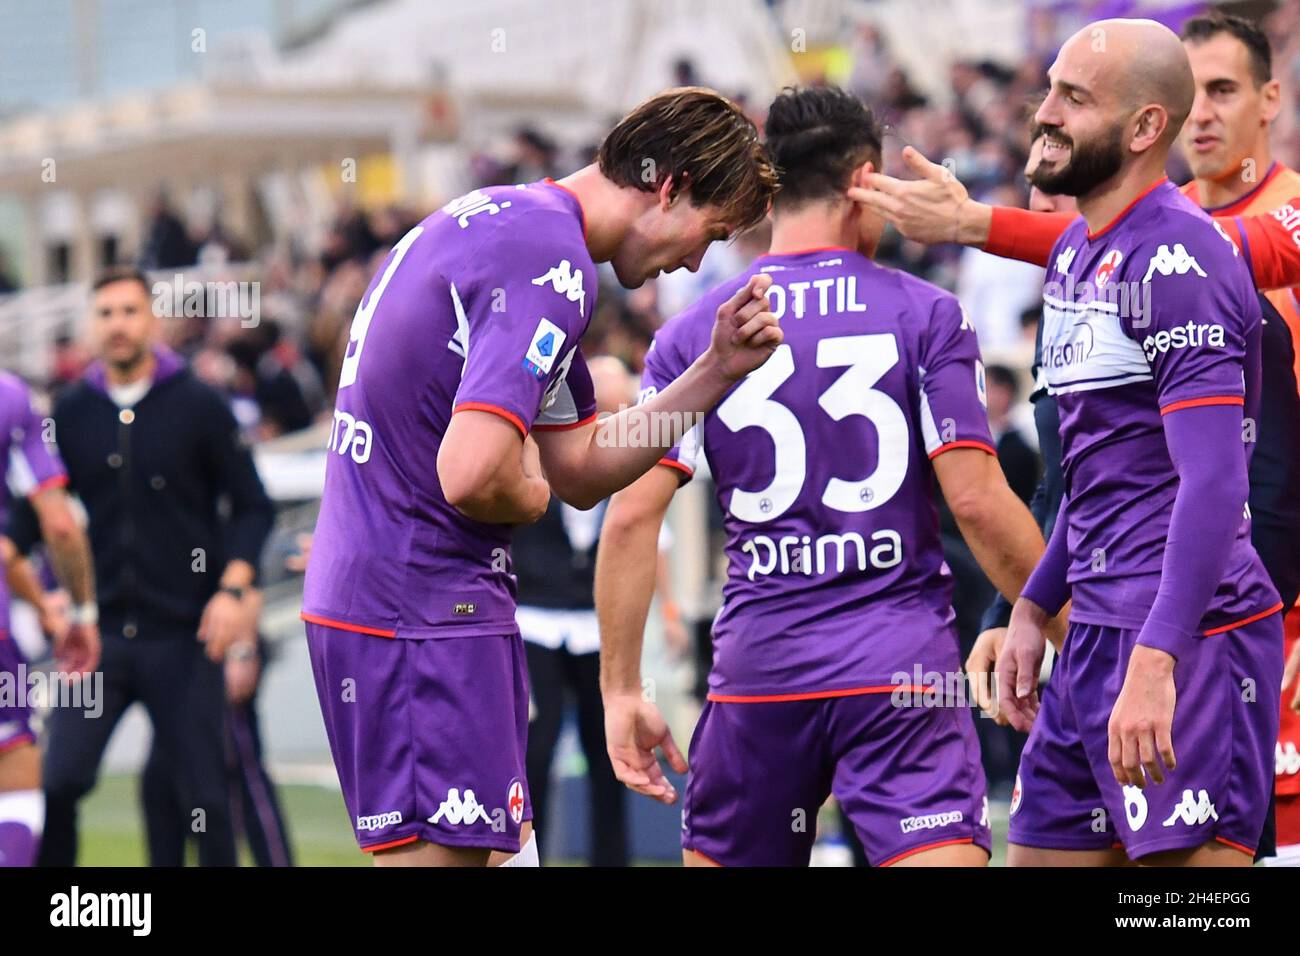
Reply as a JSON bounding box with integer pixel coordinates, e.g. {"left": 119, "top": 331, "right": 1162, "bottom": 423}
{"left": 595, "top": 88, "right": 1043, "bottom": 866}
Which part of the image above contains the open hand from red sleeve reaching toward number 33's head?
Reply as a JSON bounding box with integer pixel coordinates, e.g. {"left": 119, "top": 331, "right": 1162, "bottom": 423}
{"left": 849, "top": 146, "right": 988, "bottom": 246}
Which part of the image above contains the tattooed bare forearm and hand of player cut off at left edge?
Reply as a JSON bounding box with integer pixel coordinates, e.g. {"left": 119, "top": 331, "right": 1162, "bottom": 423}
{"left": 31, "top": 486, "right": 100, "bottom": 674}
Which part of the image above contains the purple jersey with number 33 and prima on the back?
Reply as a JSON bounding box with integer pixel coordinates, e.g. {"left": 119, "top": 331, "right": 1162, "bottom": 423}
{"left": 642, "top": 248, "right": 993, "bottom": 701}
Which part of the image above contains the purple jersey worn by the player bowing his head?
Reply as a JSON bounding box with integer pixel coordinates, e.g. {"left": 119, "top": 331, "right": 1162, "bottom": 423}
{"left": 303, "top": 182, "right": 595, "bottom": 637}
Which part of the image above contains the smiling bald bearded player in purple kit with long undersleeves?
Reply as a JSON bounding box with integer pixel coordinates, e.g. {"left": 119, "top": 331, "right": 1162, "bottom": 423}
{"left": 997, "top": 20, "right": 1282, "bottom": 866}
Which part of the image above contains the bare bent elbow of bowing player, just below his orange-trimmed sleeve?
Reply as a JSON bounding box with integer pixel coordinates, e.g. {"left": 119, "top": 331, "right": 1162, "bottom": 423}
{"left": 438, "top": 410, "right": 551, "bottom": 524}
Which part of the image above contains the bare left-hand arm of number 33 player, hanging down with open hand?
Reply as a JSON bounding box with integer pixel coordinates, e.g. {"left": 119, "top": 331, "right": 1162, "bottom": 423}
{"left": 595, "top": 468, "right": 686, "bottom": 804}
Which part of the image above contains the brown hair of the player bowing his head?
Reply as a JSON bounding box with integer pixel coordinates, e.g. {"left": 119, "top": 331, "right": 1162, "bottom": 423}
{"left": 595, "top": 86, "right": 776, "bottom": 229}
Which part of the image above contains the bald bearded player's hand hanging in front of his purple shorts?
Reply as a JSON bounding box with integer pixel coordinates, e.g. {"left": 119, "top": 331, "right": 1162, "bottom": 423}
{"left": 1106, "top": 644, "right": 1178, "bottom": 787}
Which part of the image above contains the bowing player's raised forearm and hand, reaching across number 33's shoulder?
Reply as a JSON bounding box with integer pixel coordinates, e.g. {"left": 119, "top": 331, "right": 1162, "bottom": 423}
{"left": 533, "top": 274, "right": 781, "bottom": 509}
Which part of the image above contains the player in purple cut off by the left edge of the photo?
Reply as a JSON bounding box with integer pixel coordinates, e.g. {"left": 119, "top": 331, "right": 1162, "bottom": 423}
{"left": 0, "top": 372, "right": 99, "bottom": 866}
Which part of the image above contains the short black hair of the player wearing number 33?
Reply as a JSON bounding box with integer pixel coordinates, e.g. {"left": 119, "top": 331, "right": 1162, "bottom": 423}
{"left": 766, "top": 86, "right": 881, "bottom": 207}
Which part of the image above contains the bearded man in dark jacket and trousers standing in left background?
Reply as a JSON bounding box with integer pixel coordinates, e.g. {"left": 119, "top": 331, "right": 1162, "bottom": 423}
{"left": 40, "top": 271, "right": 273, "bottom": 866}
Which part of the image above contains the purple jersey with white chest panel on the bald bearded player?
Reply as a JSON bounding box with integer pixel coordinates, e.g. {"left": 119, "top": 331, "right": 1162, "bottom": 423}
{"left": 1039, "top": 179, "right": 1278, "bottom": 633}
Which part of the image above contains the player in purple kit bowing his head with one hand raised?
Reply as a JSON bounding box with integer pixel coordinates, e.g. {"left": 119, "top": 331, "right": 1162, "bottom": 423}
{"left": 303, "top": 87, "right": 781, "bottom": 865}
